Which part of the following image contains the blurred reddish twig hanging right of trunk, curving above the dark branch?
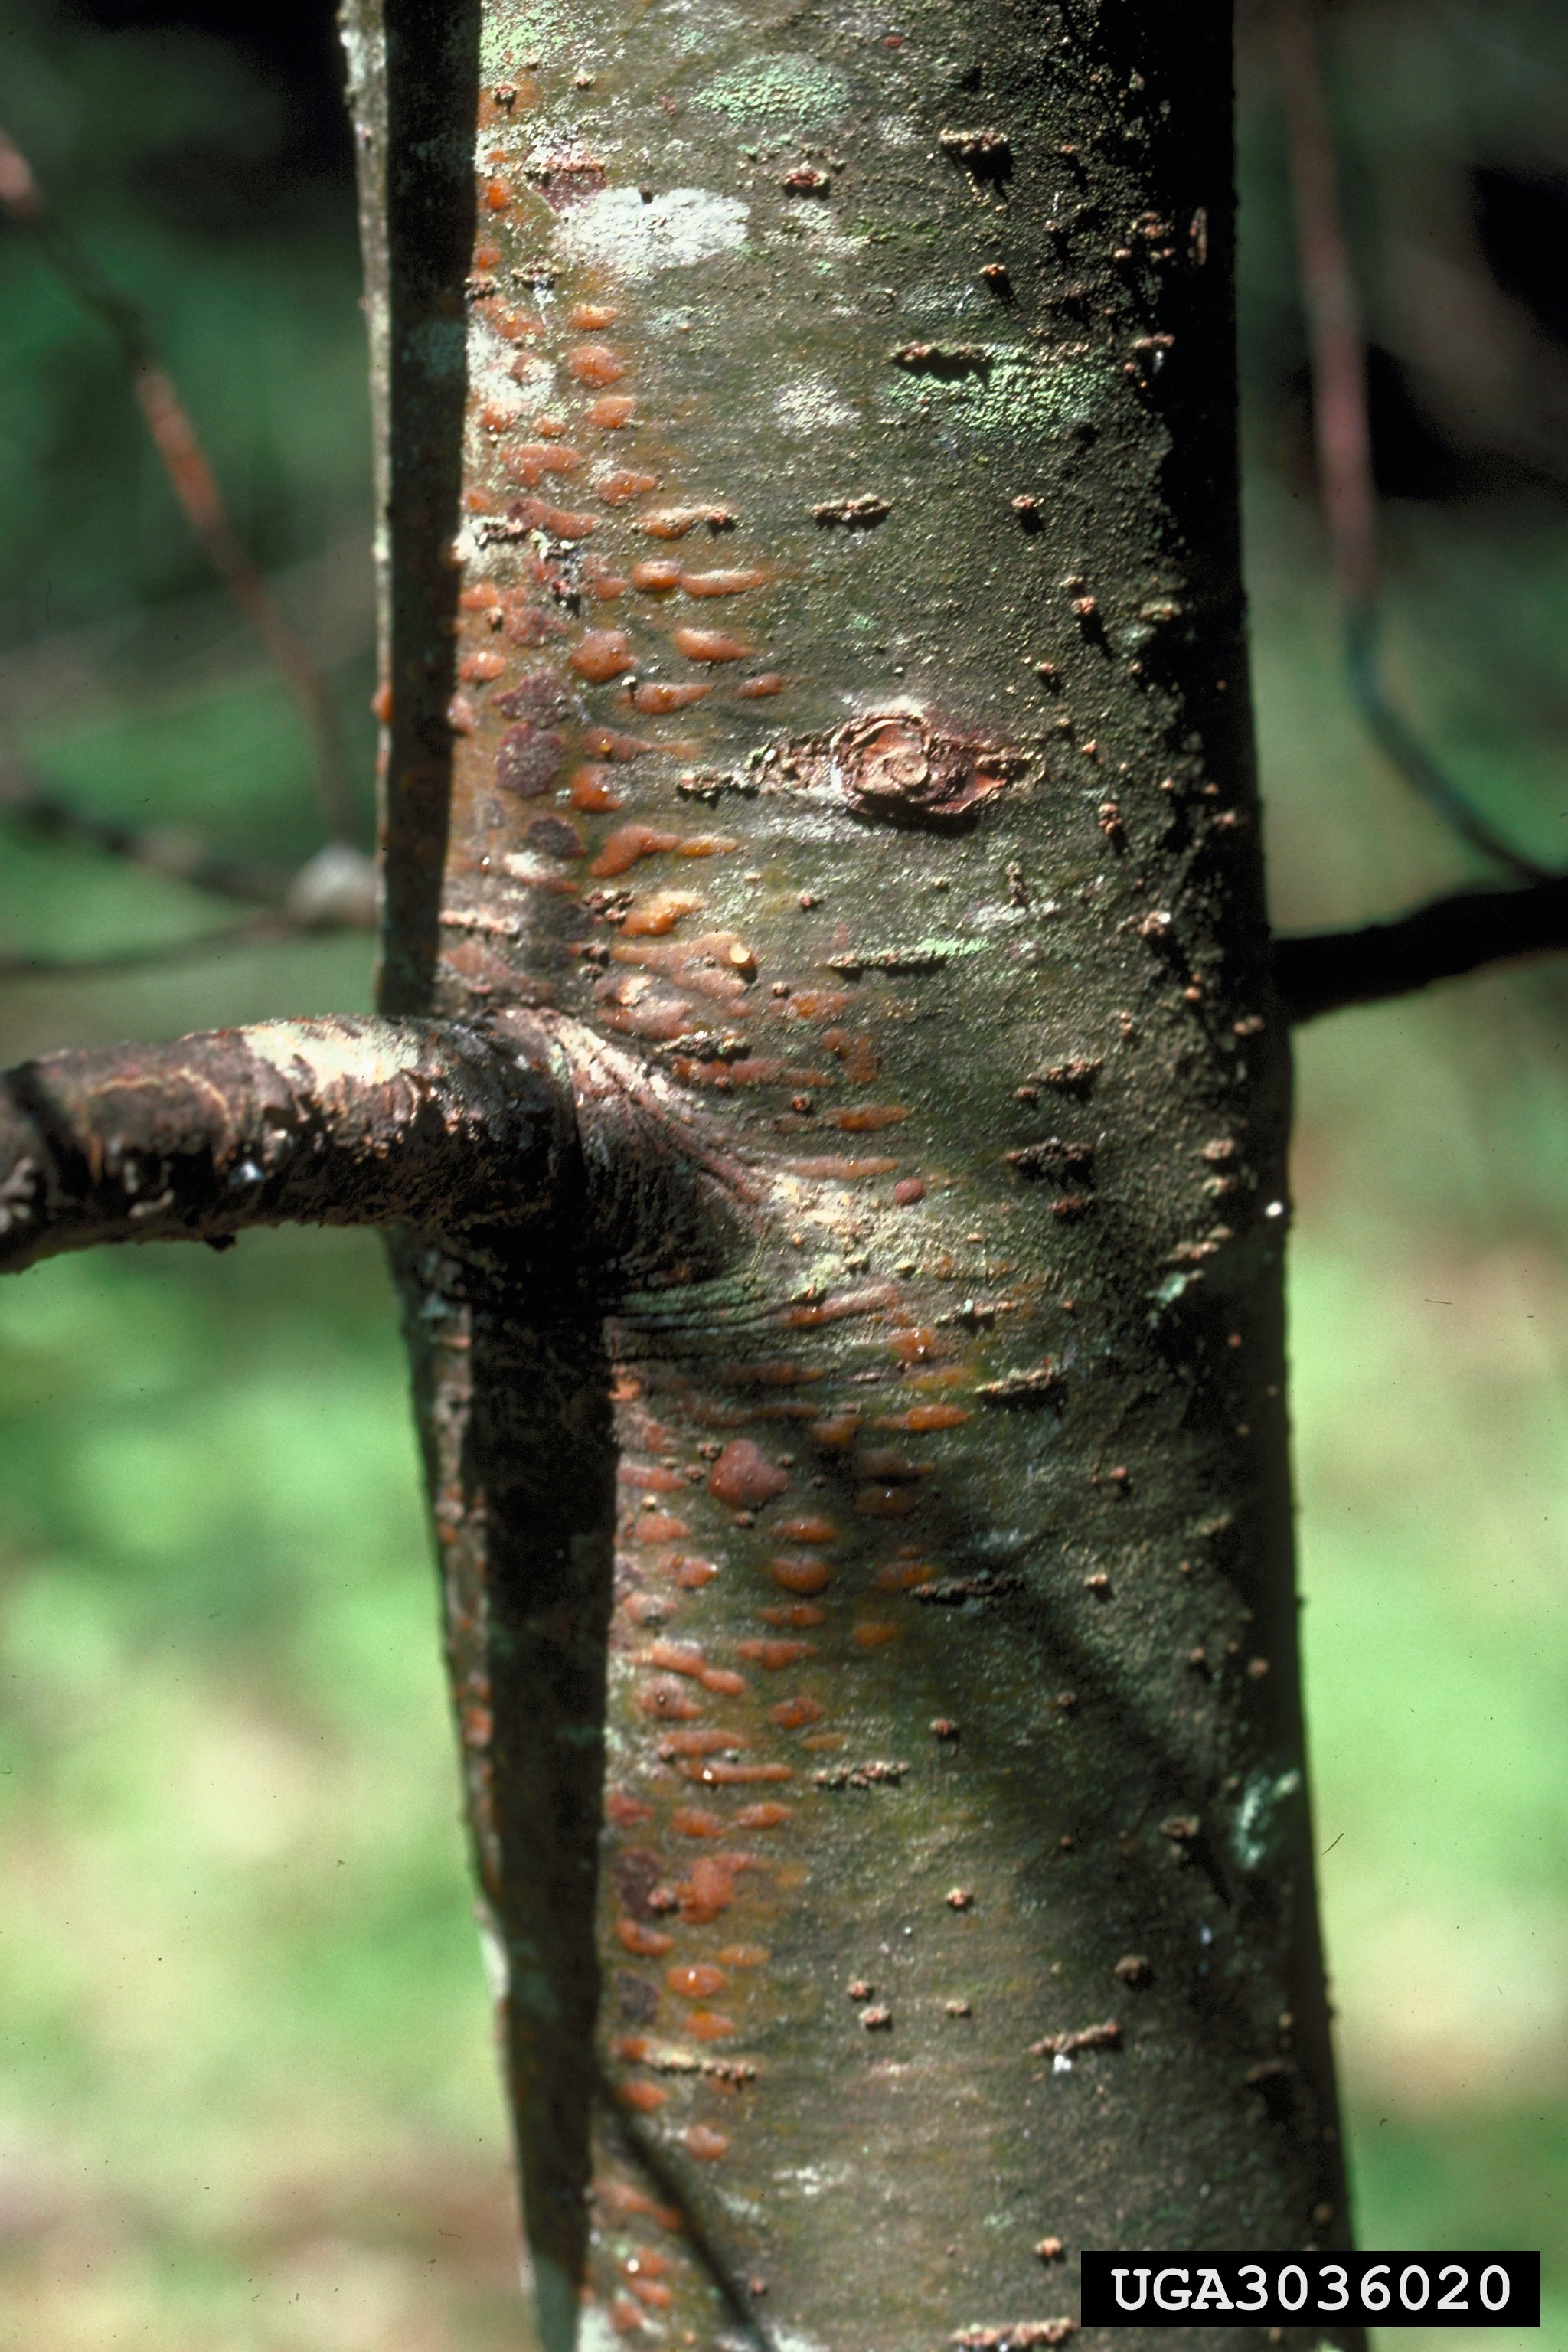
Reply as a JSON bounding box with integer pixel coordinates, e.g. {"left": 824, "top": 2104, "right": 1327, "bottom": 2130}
{"left": 1274, "top": 0, "right": 1544, "bottom": 882}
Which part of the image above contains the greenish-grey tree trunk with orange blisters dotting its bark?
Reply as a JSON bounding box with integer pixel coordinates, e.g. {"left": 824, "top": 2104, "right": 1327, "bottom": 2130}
{"left": 7, "top": 0, "right": 1359, "bottom": 2352}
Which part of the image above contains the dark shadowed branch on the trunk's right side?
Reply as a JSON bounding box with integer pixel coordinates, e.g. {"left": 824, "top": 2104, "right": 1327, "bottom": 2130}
{"left": 1274, "top": 875, "right": 1568, "bottom": 1023}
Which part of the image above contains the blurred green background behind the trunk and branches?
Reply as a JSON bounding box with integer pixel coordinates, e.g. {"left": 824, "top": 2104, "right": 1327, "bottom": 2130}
{"left": 0, "top": 0, "right": 1568, "bottom": 2352}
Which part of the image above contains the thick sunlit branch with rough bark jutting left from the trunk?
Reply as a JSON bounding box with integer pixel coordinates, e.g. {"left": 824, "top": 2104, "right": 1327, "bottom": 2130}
{"left": 0, "top": 1014, "right": 578, "bottom": 1270}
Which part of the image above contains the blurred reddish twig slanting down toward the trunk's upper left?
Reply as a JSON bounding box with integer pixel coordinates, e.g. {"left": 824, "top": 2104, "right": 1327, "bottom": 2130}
{"left": 0, "top": 132, "right": 353, "bottom": 840}
